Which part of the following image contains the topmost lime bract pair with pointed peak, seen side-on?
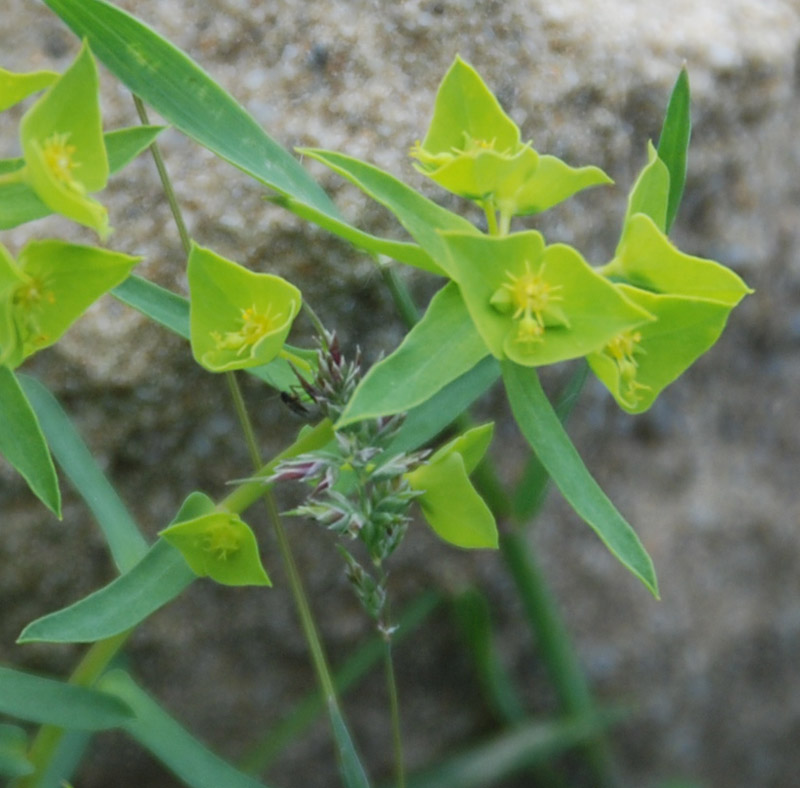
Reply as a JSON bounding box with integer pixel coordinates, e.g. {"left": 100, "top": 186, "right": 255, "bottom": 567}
{"left": 411, "top": 57, "right": 611, "bottom": 220}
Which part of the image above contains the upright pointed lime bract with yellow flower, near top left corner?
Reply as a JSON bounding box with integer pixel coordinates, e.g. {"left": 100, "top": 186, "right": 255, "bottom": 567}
{"left": 20, "top": 44, "right": 111, "bottom": 239}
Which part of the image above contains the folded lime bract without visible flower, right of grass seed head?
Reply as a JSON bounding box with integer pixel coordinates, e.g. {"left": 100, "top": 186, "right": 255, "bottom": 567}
{"left": 406, "top": 424, "right": 498, "bottom": 548}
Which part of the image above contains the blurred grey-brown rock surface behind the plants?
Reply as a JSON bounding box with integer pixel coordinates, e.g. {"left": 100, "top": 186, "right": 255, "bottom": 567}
{"left": 0, "top": 0, "right": 800, "bottom": 788}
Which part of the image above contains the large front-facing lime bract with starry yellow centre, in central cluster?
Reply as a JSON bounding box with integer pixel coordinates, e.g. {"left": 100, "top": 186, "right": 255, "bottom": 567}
{"left": 442, "top": 231, "right": 652, "bottom": 367}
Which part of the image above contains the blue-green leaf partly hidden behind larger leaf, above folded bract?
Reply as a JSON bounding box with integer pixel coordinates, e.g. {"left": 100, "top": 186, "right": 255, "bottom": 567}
{"left": 386, "top": 356, "right": 500, "bottom": 453}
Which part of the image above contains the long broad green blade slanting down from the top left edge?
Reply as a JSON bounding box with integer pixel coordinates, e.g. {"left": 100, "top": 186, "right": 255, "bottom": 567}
{"left": 45, "top": 0, "right": 340, "bottom": 219}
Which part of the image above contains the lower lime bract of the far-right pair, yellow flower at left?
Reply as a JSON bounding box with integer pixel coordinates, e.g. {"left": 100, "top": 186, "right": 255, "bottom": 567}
{"left": 586, "top": 285, "right": 732, "bottom": 413}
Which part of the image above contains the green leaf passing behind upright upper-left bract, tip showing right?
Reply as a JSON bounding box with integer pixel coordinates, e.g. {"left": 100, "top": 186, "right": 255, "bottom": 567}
{"left": 0, "top": 126, "right": 164, "bottom": 230}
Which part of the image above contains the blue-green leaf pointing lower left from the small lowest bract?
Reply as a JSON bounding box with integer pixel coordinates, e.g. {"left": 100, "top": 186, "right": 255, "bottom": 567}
{"left": 17, "top": 540, "right": 197, "bottom": 643}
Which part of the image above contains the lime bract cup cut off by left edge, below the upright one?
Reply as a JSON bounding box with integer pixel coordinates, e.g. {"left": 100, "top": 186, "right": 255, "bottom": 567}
{"left": 0, "top": 241, "right": 141, "bottom": 369}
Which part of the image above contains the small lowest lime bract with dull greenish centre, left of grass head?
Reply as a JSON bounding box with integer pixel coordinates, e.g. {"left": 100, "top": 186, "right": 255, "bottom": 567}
{"left": 159, "top": 512, "right": 272, "bottom": 586}
